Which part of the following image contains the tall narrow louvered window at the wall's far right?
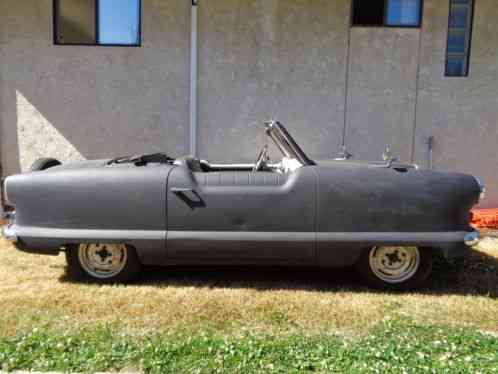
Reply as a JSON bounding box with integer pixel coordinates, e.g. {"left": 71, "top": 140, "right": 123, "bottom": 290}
{"left": 445, "top": 0, "right": 474, "bottom": 77}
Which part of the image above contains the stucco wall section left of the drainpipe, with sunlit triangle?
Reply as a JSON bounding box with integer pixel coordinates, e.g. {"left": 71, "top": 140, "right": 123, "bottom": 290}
{"left": 0, "top": 0, "right": 190, "bottom": 174}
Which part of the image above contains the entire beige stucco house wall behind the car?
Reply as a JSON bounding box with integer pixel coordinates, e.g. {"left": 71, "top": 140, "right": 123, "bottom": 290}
{"left": 0, "top": 0, "right": 498, "bottom": 206}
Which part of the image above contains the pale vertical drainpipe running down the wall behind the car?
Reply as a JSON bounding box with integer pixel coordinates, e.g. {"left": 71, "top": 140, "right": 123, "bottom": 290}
{"left": 190, "top": 0, "right": 199, "bottom": 157}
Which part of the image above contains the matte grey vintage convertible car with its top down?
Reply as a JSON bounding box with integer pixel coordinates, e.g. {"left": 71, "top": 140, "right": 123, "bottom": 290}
{"left": 3, "top": 121, "right": 484, "bottom": 290}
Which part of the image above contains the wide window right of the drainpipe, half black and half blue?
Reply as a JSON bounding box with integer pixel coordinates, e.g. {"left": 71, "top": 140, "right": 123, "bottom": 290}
{"left": 352, "top": 0, "right": 423, "bottom": 27}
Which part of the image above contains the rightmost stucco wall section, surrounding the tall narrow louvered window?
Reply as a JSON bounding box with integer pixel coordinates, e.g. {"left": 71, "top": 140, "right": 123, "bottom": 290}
{"left": 415, "top": 0, "right": 498, "bottom": 207}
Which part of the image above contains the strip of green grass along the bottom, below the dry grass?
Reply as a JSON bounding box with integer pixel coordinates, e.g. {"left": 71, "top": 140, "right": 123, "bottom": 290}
{"left": 0, "top": 319, "right": 498, "bottom": 373}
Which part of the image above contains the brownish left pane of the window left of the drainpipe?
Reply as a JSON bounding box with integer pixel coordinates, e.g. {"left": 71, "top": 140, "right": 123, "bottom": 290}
{"left": 56, "top": 0, "right": 96, "bottom": 44}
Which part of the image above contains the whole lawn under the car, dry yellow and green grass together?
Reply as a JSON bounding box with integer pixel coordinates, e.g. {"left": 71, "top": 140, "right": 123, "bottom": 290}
{"left": 0, "top": 239, "right": 498, "bottom": 373}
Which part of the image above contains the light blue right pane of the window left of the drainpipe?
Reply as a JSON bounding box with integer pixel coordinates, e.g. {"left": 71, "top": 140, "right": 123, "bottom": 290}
{"left": 99, "top": 0, "right": 140, "bottom": 45}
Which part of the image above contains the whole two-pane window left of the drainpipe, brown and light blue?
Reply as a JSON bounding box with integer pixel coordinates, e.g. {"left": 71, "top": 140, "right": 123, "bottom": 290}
{"left": 54, "top": 0, "right": 141, "bottom": 46}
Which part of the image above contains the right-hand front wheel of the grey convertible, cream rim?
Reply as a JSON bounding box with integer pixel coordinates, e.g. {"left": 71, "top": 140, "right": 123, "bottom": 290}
{"left": 357, "top": 246, "right": 432, "bottom": 290}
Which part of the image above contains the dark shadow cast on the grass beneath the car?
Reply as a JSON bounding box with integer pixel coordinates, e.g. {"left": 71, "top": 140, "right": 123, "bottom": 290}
{"left": 60, "top": 251, "right": 498, "bottom": 298}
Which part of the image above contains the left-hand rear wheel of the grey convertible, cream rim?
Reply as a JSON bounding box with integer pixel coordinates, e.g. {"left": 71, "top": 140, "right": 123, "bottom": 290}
{"left": 66, "top": 243, "right": 141, "bottom": 283}
